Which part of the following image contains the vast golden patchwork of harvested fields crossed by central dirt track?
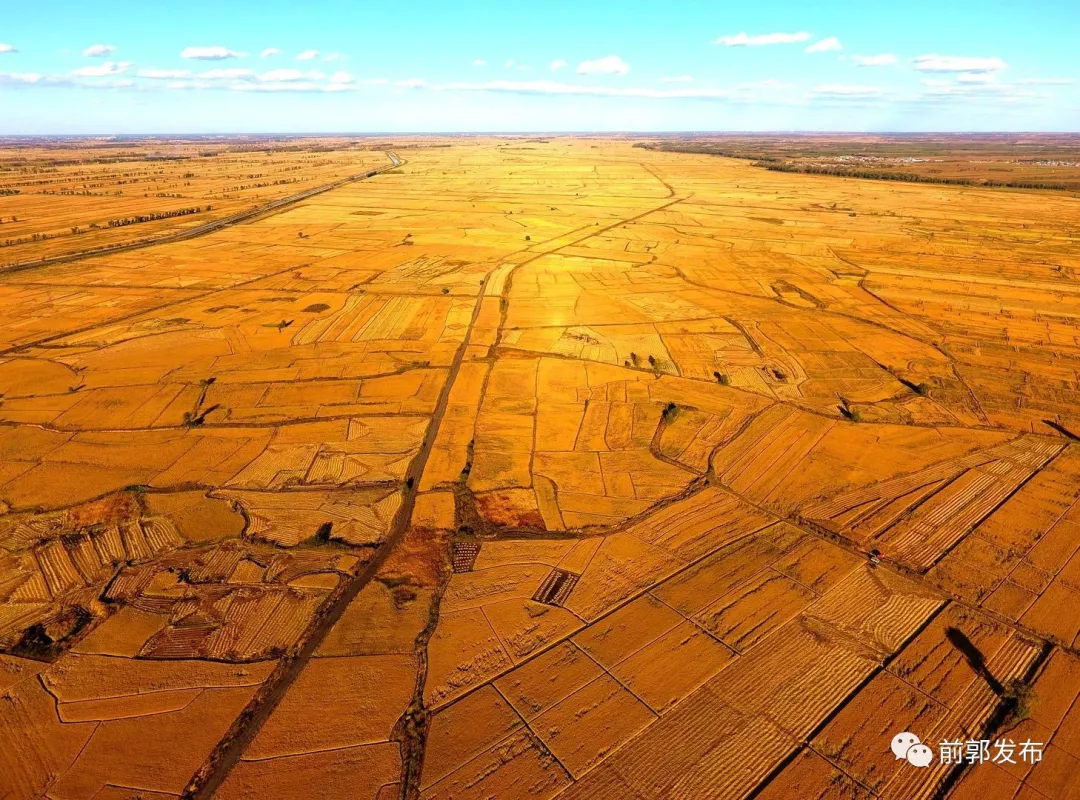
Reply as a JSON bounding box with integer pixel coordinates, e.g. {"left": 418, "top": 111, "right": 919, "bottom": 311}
{"left": 0, "top": 138, "right": 1080, "bottom": 800}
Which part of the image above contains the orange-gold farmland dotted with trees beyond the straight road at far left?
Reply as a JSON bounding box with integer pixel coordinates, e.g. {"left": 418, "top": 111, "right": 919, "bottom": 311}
{"left": 0, "top": 137, "right": 387, "bottom": 263}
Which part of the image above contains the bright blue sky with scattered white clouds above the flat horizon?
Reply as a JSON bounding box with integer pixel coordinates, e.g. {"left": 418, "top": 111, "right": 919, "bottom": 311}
{"left": 0, "top": 0, "right": 1080, "bottom": 135}
